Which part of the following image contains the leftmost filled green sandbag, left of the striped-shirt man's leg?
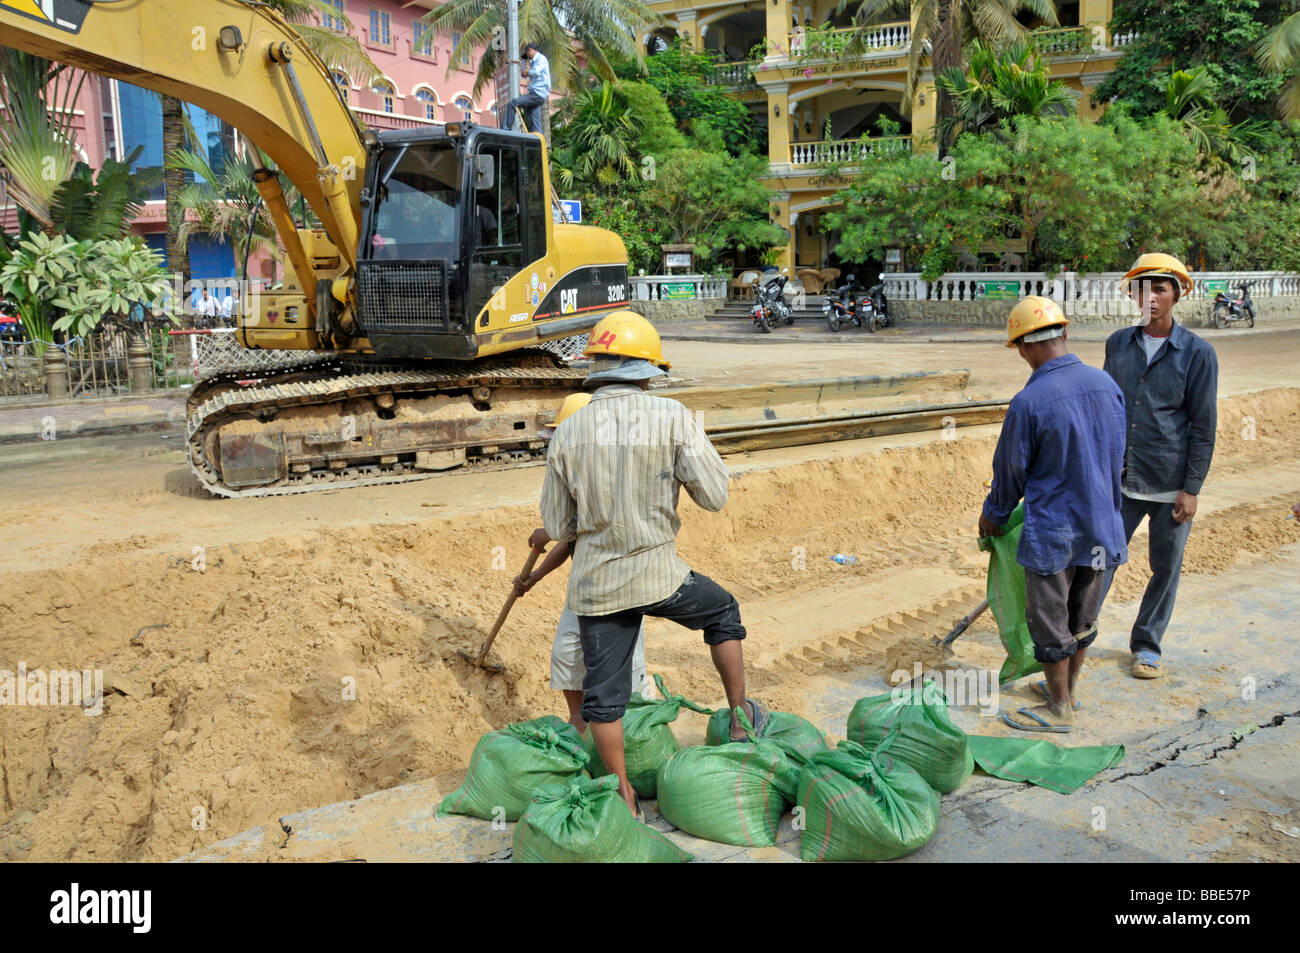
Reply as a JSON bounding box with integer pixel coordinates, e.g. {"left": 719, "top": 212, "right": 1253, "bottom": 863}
{"left": 438, "top": 715, "right": 588, "bottom": 820}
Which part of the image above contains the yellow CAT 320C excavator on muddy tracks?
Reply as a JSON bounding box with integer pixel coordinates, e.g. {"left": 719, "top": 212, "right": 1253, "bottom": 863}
{"left": 0, "top": 0, "right": 629, "bottom": 497}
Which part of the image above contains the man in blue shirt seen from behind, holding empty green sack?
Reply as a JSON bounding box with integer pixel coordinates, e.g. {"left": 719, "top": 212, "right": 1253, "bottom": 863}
{"left": 979, "top": 296, "right": 1128, "bottom": 733}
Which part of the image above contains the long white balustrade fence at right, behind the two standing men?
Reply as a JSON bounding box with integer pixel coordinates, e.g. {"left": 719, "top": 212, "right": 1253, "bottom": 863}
{"left": 884, "top": 272, "right": 1300, "bottom": 317}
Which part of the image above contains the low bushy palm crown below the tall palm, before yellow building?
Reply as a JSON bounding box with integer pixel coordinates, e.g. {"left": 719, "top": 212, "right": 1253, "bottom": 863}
{"left": 935, "top": 39, "right": 1074, "bottom": 142}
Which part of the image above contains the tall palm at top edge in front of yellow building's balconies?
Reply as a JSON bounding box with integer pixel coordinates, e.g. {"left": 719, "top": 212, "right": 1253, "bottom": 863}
{"left": 836, "top": 0, "right": 1060, "bottom": 156}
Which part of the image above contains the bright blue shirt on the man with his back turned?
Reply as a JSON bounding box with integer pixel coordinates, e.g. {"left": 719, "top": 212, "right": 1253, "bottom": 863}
{"left": 984, "top": 354, "right": 1128, "bottom": 576}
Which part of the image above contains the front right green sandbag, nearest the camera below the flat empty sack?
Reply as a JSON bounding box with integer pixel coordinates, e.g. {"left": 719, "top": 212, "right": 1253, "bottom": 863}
{"left": 800, "top": 740, "right": 939, "bottom": 861}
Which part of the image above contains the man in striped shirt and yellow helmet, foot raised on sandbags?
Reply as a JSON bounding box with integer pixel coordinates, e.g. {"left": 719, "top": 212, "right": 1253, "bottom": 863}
{"left": 541, "top": 311, "right": 767, "bottom": 818}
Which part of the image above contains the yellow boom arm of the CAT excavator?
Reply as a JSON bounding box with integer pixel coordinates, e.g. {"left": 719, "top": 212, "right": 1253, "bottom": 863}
{"left": 0, "top": 0, "right": 365, "bottom": 297}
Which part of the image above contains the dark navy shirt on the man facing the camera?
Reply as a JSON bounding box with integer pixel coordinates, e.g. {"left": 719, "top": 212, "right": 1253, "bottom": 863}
{"left": 1105, "top": 322, "right": 1218, "bottom": 495}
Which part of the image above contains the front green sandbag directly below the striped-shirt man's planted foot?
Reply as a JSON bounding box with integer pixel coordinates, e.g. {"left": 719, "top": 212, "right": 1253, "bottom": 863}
{"left": 514, "top": 775, "right": 693, "bottom": 863}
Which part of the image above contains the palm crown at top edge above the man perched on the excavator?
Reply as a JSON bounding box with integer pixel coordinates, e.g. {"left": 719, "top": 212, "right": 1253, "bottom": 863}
{"left": 421, "top": 0, "right": 663, "bottom": 98}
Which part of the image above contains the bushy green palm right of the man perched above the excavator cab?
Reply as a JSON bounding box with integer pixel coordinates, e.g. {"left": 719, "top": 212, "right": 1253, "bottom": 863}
{"left": 556, "top": 81, "right": 641, "bottom": 189}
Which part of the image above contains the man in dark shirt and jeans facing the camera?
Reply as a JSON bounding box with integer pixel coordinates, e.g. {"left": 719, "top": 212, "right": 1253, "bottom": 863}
{"left": 1102, "top": 254, "right": 1218, "bottom": 679}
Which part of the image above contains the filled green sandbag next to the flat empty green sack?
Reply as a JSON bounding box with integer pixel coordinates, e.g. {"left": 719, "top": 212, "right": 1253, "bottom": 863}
{"left": 846, "top": 681, "right": 975, "bottom": 794}
